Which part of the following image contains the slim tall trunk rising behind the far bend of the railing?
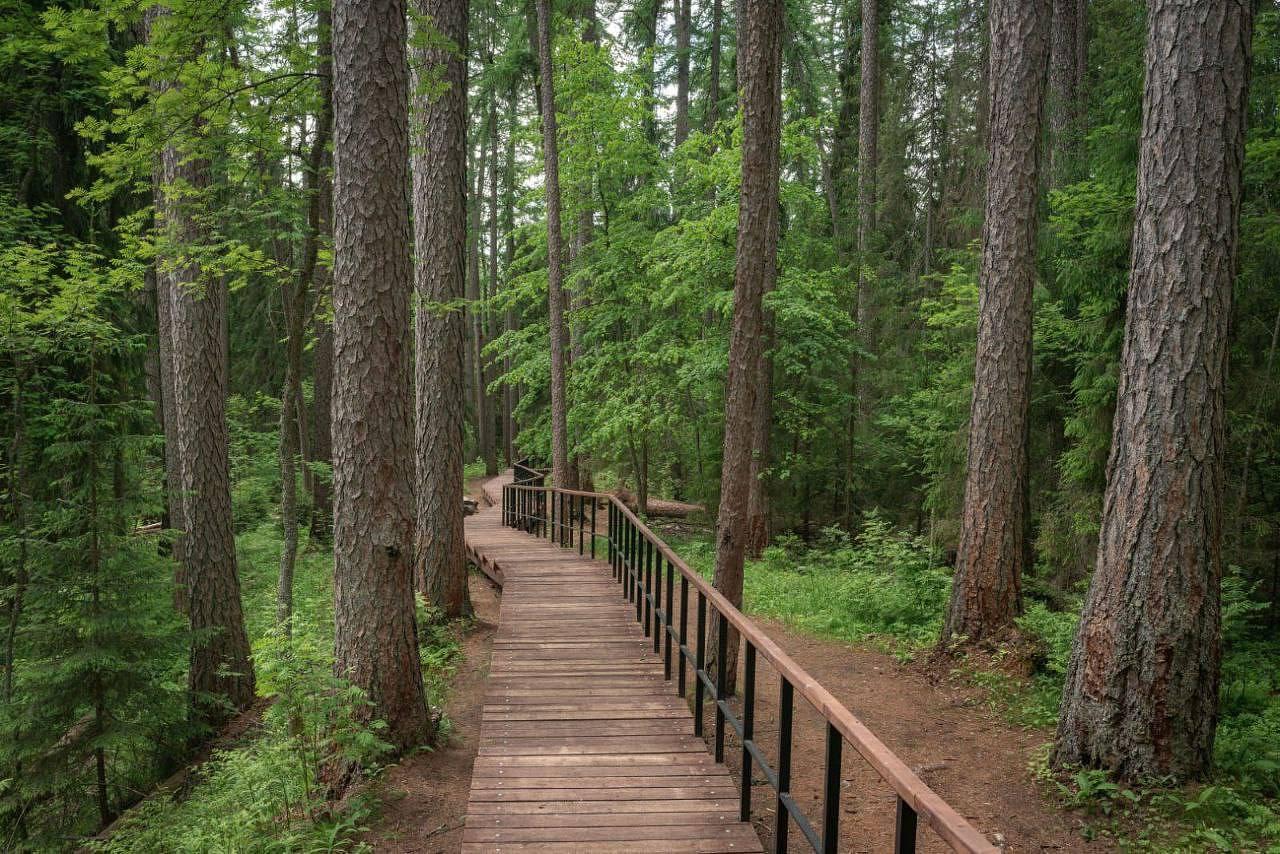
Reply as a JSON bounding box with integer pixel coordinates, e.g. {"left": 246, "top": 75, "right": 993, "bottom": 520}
{"left": 535, "top": 0, "right": 573, "bottom": 487}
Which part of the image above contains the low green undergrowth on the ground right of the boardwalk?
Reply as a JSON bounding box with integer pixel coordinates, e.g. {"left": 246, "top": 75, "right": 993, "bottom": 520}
{"left": 664, "top": 516, "right": 1280, "bottom": 854}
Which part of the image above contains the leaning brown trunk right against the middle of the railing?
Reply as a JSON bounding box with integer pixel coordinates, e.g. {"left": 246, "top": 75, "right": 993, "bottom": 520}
{"left": 712, "top": 0, "right": 783, "bottom": 688}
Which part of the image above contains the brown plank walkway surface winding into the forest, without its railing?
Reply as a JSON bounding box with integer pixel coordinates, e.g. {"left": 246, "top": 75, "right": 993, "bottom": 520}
{"left": 462, "top": 475, "right": 762, "bottom": 854}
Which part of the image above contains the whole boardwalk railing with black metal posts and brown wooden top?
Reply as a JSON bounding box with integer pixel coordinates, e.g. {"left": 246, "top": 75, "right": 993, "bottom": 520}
{"left": 502, "top": 484, "right": 1000, "bottom": 854}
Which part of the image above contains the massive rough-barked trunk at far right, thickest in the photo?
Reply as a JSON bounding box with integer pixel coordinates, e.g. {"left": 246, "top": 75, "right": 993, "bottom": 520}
{"left": 1055, "top": 0, "right": 1253, "bottom": 780}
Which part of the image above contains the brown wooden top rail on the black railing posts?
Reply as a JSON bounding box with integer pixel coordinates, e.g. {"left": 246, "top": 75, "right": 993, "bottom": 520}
{"left": 501, "top": 484, "right": 1000, "bottom": 854}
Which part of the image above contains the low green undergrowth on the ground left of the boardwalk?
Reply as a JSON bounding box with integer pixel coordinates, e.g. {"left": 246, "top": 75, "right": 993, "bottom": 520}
{"left": 93, "top": 522, "right": 462, "bottom": 854}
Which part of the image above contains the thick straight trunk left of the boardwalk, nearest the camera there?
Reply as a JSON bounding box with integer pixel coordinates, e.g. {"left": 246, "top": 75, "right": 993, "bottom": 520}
{"left": 333, "top": 0, "right": 430, "bottom": 750}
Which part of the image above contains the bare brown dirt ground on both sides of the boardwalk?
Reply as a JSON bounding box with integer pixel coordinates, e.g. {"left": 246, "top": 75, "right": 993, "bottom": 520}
{"left": 365, "top": 491, "right": 1090, "bottom": 854}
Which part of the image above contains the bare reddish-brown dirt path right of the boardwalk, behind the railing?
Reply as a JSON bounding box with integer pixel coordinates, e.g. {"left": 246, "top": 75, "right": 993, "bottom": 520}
{"left": 708, "top": 620, "right": 1110, "bottom": 854}
